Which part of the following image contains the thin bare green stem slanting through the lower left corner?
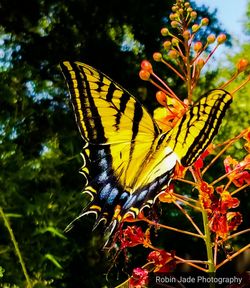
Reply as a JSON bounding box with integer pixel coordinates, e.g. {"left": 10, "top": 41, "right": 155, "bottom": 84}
{"left": 0, "top": 207, "right": 32, "bottom": 288}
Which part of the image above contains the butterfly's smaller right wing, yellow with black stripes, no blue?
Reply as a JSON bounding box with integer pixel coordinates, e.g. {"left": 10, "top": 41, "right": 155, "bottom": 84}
{"left": 168, "top": 89, "right": 232, "bottom": 167}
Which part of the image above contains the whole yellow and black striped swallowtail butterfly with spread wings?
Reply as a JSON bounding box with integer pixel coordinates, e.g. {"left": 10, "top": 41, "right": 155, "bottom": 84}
{"left": 61, "top": 61, "right": 232, "bottom": 240}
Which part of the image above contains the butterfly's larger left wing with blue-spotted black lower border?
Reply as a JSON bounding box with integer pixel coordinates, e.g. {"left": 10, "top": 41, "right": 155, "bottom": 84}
{"left": 61, "top": 61, "right": 176, "bottom": 225}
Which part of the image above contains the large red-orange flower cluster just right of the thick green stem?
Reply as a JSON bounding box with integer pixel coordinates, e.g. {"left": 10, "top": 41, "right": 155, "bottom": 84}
{"left": 200, "top": 182, "right": 242, "bottom": 238}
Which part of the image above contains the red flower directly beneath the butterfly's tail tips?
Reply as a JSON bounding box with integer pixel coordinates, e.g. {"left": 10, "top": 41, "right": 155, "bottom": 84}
{"left": 119, "top": 226, "right": 150, "bottom": 249}
